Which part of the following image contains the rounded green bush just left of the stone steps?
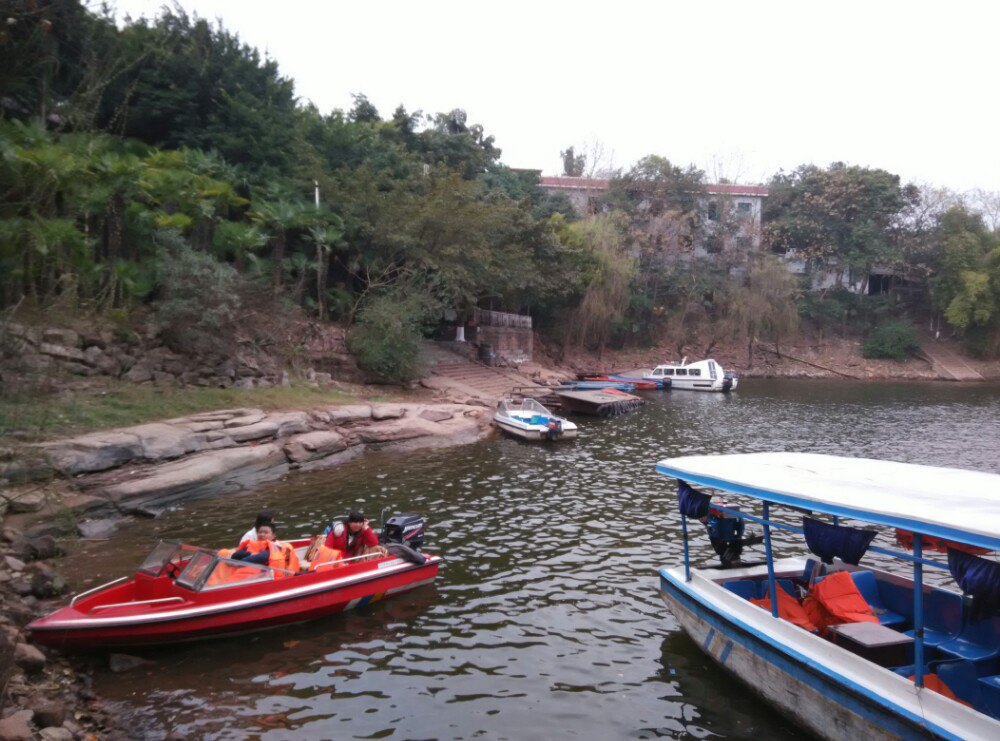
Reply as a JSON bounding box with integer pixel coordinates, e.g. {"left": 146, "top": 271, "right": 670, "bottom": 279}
{"left": 348, "top": 289, "right": 440, "bottom": 384}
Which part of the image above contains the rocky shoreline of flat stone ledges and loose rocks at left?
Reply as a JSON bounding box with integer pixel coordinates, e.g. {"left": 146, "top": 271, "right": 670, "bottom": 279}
{"left": 0, "top": 403, "right": 491, "bottom": 741}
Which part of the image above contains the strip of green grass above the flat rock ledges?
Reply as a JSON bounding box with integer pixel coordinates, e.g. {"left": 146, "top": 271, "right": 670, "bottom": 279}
{"left": 0, "top": 385, "right": 355, "bottom": 440}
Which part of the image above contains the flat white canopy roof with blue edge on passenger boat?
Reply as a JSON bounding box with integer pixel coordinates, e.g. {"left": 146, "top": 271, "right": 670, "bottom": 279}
{"left": 656, "top": 453, "right": 1000, "bottom": 550}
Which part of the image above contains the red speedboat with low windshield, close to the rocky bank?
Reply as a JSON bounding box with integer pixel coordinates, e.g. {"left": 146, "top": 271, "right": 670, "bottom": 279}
{"left": 28, "top": 540, "right": 441, "bottom": 649}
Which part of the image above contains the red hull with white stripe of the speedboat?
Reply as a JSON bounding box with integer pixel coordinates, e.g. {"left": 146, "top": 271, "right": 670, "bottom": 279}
{"left": 29, "top": 556, "right": 441, "bottom": 650}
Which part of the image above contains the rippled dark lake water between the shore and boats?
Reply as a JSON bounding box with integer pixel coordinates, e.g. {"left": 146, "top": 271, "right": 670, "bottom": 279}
{"left": 66, "top": 380, "right": 1000, "bottom": 740}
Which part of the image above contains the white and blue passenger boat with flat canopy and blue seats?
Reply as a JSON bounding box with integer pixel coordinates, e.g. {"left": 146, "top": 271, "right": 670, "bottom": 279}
{"left": 656, "top": 453, "right": 1000, "bottom": 741}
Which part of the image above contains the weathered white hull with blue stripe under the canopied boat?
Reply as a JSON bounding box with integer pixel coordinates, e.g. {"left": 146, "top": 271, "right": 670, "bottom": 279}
{"left": 660, "top": 569, "right": 996, "bottom": 741}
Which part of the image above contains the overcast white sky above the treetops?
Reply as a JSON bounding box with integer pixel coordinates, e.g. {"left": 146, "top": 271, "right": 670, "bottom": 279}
{"left": 107, "top": 0, "right": 1000, "bottom": 191}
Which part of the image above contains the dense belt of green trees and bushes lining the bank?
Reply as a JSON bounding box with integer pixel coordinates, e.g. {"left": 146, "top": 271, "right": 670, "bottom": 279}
{"left": 0, "top": 0, "right": 1000, "bottom": 382}
